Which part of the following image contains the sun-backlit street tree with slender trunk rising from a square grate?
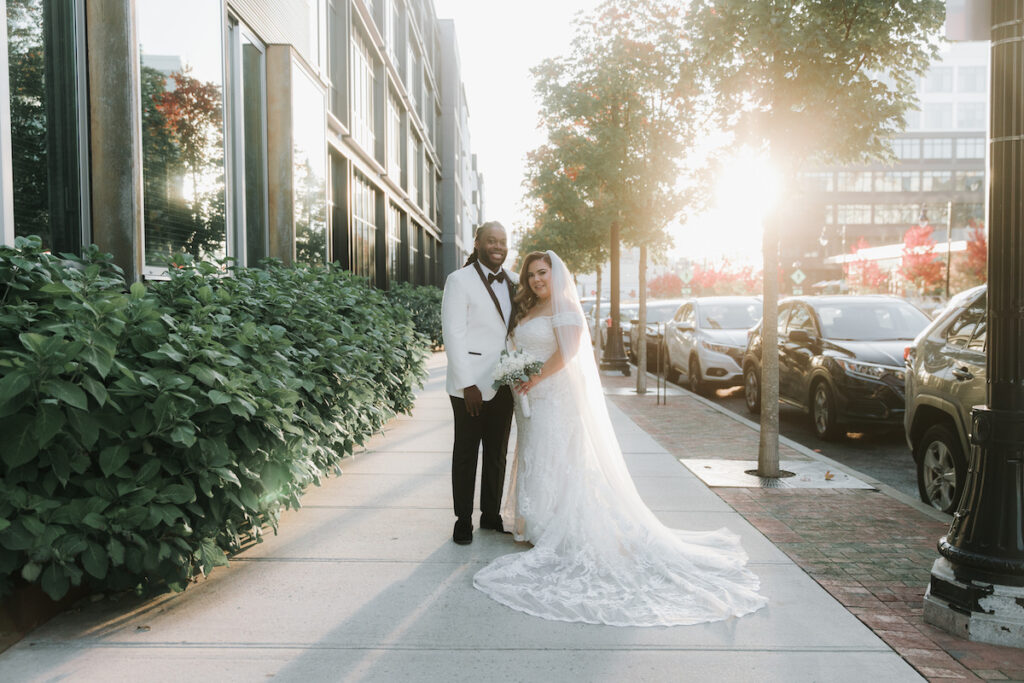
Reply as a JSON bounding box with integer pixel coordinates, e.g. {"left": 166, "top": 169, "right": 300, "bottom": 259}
{"left": 689, "top": 0, "right": 945, "bottom": 477}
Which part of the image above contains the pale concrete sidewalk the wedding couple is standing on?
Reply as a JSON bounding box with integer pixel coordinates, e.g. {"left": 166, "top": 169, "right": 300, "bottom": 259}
{"left": 0, "top": 355, "right": 921, "bottom": 682}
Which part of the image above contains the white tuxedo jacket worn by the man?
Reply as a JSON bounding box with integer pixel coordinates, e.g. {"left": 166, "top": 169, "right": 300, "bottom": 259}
{"left": 441, "top": 264, "right": 515, "bottom": 400}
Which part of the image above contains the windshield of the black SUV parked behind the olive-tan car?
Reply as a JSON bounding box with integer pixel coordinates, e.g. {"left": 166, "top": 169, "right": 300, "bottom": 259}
{"left": 814, "top": 301, "right": 930, "bottom": 341}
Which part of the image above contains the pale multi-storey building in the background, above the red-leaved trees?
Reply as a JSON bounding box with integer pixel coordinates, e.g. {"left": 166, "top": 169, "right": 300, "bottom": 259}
{"left": 781, "top": 42, "right": 989, "bottom": 287}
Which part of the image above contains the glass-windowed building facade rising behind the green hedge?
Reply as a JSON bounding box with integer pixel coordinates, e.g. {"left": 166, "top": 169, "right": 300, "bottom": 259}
{"left": 0, "top": 0, "right": 479, "bottom": 287}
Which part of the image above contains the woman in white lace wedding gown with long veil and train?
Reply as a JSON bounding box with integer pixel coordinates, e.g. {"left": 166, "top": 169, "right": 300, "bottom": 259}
{"left": 473, "top": 251, "right": 767, "bottom": 626}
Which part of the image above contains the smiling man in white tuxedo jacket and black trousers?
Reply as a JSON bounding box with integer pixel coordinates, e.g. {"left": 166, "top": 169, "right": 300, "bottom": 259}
{"left": 441, "top": 220, "right": 515, "bottom": 546}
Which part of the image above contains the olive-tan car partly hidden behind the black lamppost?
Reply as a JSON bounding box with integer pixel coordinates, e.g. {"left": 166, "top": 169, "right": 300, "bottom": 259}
{"left": 903, "top": 285, "right": 987, "bottom": 513}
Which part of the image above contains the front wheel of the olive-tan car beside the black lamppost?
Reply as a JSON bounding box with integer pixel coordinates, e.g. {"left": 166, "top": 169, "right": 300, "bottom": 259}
{"left": 914, "top": 425, "right": 967, "bottom": 514}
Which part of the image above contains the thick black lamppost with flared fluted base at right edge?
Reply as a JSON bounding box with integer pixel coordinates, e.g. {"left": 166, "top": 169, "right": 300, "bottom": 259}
{"left": 925, "top": 0, "right": 1024, "bottom": 647}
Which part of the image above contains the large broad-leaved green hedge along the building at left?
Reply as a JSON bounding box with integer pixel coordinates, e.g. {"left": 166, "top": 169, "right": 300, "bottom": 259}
{"left": 0, "top": 238, "right": 426, "bottom": 599}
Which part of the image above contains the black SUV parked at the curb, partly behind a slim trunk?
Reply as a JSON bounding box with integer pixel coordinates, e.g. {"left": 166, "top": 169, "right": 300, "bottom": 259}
{"left": 743, "top": 296, "right": 930, "bottom": 439}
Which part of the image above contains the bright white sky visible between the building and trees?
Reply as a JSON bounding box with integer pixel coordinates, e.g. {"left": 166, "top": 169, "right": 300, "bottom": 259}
{"left": 434, "top": 0, "right": 761, "bottom": 263}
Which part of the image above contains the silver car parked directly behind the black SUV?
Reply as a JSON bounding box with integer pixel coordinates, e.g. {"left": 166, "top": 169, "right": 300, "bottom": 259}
{"left": 664, "top": 296, "right": 761, "bottom": 394}
